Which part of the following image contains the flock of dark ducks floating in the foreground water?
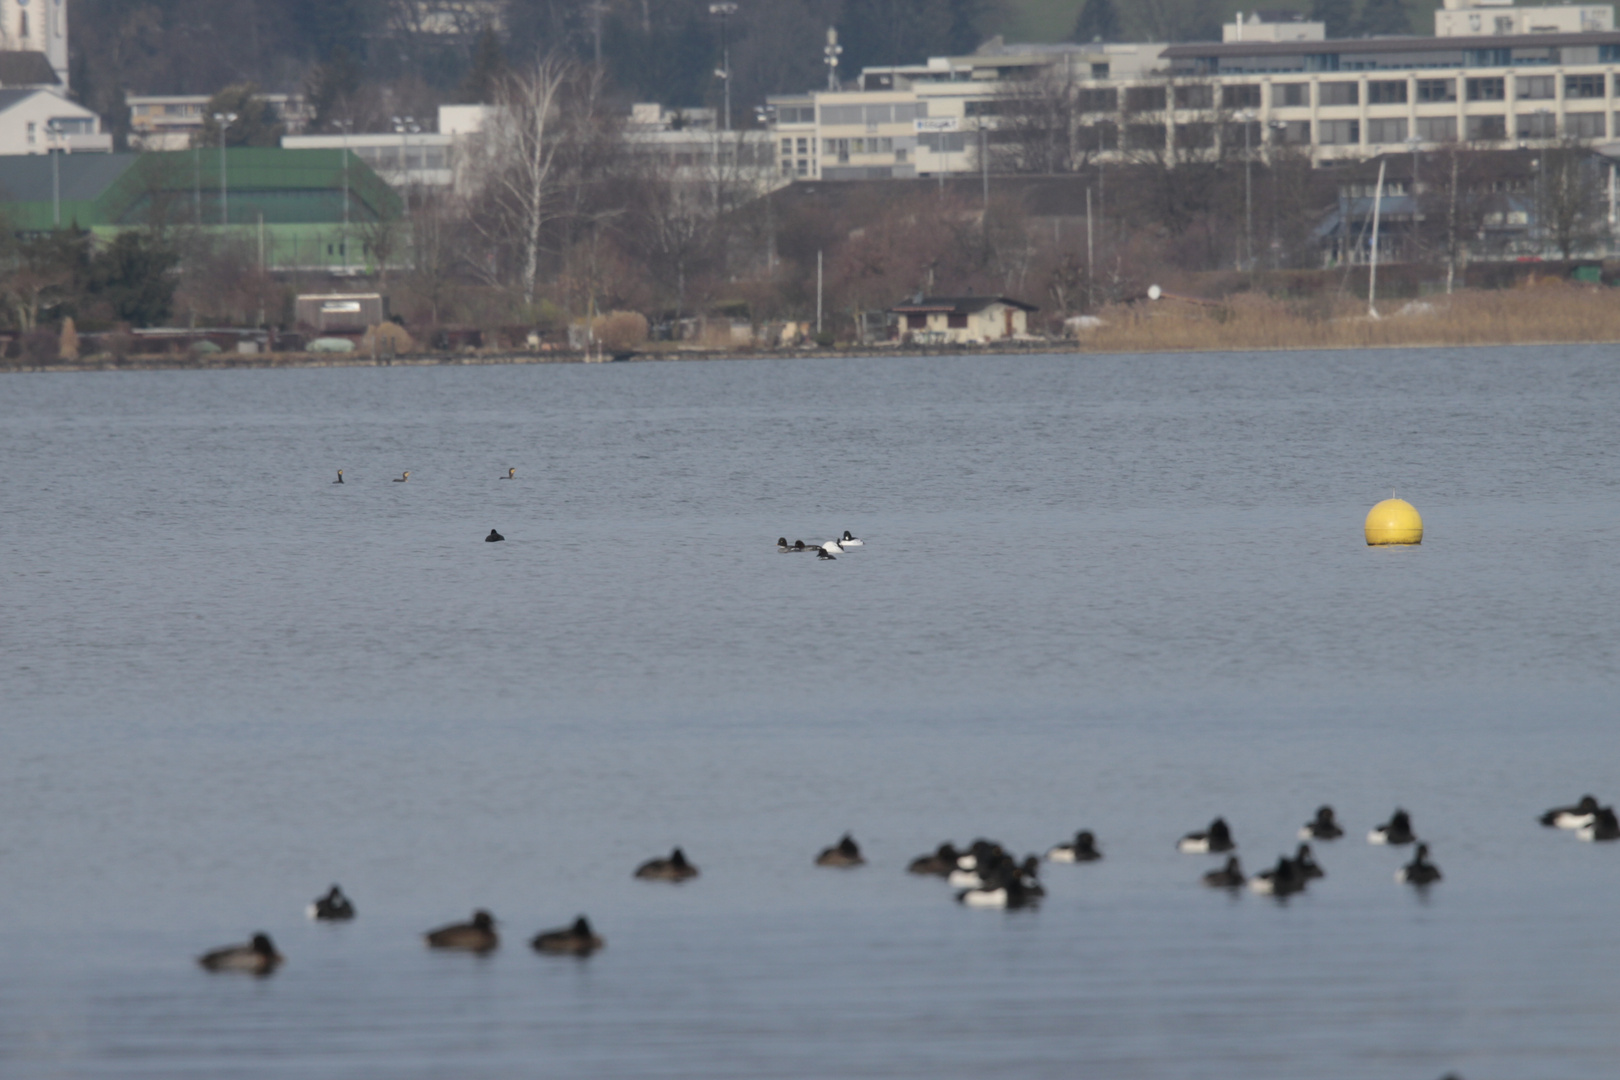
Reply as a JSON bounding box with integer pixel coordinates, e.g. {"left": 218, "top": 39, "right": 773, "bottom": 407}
{"left": 198, "top": 795, "right": 1620, "bottom": 975}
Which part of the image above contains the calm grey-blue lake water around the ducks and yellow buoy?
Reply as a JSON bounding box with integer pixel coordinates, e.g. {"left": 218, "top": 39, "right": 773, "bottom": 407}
{"left": 0, "top": 347, "right": 1620, "bottom": 1080}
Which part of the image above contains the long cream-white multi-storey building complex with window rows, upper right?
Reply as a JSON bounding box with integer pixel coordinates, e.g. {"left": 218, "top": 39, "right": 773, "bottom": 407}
{"left": 770, "top": 0, "right": 1620, "bottom": 180}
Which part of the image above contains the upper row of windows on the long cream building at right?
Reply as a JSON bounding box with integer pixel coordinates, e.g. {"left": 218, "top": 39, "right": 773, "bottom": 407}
{"left": 1075, "top": 74, "right": 1620, "bottom": 112}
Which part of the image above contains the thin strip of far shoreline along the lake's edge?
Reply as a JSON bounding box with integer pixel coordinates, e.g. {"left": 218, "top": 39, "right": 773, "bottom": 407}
{"left": 0, "top": 338, "right": 1620, "bottom": 374}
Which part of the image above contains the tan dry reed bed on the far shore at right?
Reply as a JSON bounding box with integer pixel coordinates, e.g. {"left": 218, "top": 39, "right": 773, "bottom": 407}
{"left": 1079, "top": 283, "right": 1620, "bottom": 353}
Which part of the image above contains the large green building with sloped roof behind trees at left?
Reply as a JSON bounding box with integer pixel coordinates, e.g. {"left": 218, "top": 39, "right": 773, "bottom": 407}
{"left": 0, "top": 147, "right": 405, "bottom": 269}
